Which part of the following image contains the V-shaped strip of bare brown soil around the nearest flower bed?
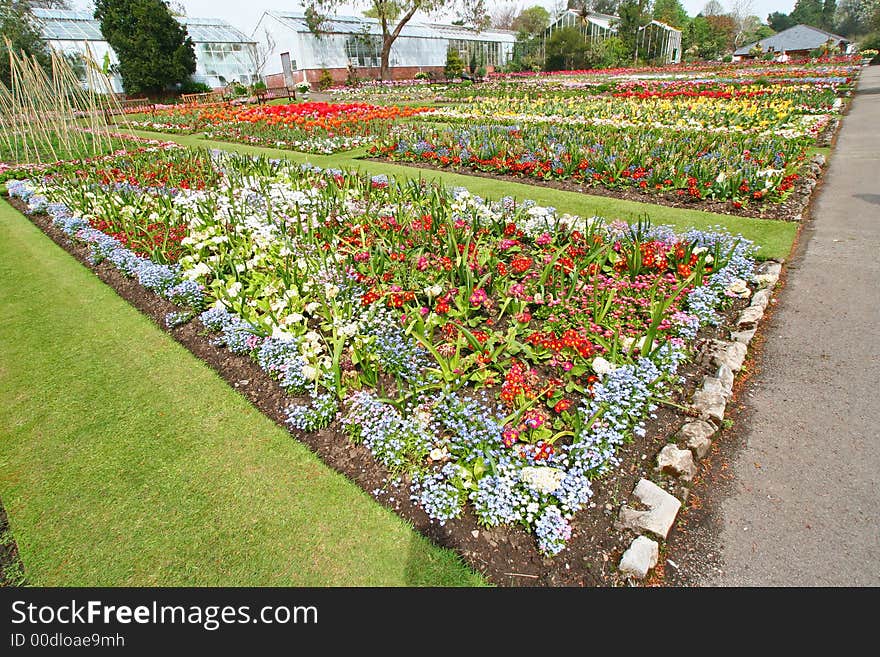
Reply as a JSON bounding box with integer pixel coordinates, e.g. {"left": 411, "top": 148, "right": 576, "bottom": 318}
{"left": 12, "top": 201, "right": 746, "bottom": 586}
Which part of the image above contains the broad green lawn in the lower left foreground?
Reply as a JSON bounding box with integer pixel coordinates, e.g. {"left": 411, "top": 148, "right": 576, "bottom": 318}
{"left": 0, "top": 201, "right": 483, "bottom": 586}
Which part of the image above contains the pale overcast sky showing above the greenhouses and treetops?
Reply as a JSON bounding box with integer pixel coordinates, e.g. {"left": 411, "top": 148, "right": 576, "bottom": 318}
{"left": 74, "top": 0, "right": 795, "bottom": 34}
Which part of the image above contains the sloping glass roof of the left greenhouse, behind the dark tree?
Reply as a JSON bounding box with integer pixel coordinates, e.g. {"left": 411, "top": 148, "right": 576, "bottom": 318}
{"left": 32, "top": 8, "right": 254, "bottom": 43}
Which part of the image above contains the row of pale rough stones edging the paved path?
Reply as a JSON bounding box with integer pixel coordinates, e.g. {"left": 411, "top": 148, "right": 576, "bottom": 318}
{"left": 616, "top": 261, "right": 782, "bottom": 581}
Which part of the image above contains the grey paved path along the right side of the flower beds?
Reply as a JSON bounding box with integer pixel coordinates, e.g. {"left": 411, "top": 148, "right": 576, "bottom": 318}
{"left": 666, "top": 66, "right": 880, "bottom": 586}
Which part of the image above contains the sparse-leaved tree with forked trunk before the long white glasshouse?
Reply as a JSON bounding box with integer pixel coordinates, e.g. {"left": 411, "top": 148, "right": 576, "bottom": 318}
{"left": 305, "top": 0, "right": 488, "bottom": 80}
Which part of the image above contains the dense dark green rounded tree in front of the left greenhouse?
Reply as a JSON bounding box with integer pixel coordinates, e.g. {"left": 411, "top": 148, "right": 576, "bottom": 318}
{"left": 95, "top": 0, "right": 196, "bottom": 95}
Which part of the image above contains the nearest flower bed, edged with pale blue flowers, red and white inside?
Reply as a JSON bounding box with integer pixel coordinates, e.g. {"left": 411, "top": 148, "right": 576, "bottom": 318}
{"left": 9, "top": 151, "right": 753, "bottom": 555}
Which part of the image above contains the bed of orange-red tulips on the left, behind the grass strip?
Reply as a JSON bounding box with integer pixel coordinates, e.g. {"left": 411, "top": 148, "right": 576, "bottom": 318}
{"left": 133, "top": 103, "right": 434, "bottom": 154}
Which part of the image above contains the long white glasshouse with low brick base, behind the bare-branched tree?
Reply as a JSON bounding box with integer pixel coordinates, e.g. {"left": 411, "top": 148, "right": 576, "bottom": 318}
{"left": 253, "top": 11, "right": 516, "bottom": 86}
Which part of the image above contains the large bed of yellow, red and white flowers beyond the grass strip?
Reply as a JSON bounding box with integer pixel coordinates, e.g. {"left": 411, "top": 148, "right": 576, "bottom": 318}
{"left": 370, "top": 64, "right": 857, "bottom": 210}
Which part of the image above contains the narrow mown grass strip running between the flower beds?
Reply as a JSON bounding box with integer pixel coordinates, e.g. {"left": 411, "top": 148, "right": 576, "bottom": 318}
{"left": 122, "top": 130, "right": 798, "bottom": 259}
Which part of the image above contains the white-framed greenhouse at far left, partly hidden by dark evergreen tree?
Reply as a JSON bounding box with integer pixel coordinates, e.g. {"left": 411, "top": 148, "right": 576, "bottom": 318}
{"left": 32, "top": 9, "right": 257, "bottom": 93}
